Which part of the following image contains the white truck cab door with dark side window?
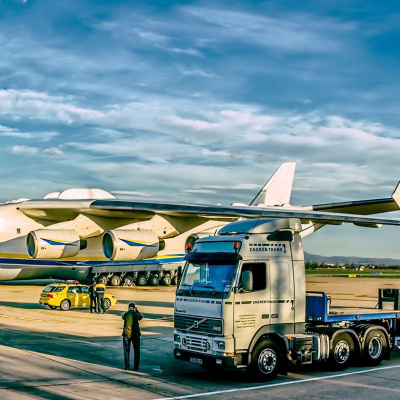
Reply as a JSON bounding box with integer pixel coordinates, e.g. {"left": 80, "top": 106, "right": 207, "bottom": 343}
{"left": 234, "top": 261, "right": 271, "bottom": 350}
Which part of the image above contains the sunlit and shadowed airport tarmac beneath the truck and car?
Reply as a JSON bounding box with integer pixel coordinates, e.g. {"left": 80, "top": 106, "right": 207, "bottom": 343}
{"left": 0, "top": 277, "right": 400, "bottom": 400}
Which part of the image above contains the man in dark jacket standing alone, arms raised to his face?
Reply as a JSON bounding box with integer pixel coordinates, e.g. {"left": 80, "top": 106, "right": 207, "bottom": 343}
{"left": 122, "top": 303, "right": 143, "bottom": 371}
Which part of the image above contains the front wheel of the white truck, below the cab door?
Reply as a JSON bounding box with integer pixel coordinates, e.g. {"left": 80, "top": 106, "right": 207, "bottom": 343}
{"left": 248, "top": 339, "right": 282, "bottom": 381}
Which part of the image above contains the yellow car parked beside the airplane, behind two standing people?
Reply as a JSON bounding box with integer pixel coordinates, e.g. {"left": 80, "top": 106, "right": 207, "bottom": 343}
{"left": 39, "top": 283, "right": 117, "bottom": 311}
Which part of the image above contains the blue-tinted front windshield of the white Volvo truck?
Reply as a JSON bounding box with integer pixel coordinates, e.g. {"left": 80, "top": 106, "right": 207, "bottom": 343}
{"left": 178, "top": 262, "right": 236, "bottom": 297}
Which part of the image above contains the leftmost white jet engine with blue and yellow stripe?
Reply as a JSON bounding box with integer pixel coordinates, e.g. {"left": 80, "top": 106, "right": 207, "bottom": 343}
{"left": 26, "top": 229, "right": 82, "bottom": 259}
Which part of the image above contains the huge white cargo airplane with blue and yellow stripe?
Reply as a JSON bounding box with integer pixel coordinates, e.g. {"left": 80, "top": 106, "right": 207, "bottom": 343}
{"left": 0, "top": 163, "right": 400, "bottom": 280}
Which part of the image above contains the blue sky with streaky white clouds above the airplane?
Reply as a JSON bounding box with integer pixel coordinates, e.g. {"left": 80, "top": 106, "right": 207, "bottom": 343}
{"left": 0, "top": 0, "right": 400, "bottom": 258}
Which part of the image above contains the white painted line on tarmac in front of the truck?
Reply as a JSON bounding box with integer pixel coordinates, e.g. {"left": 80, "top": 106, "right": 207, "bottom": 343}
{"left": 154, "top": 365, "right": 400, "bottom": 400}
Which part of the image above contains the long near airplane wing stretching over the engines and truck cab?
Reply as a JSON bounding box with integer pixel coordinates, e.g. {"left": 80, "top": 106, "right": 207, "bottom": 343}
{"left": 18, "top": 199, "right": 400, "bottom": 233}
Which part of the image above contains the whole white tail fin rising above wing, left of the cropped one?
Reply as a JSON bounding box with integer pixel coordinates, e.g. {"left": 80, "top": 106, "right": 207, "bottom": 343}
{"left": 250, "top": 163, "right": 296, "bottom": 206}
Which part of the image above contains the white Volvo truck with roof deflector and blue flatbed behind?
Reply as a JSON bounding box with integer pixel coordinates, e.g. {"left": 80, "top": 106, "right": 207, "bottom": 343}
{"left": 174, "top": 218, "right": 400, "bottom": 380}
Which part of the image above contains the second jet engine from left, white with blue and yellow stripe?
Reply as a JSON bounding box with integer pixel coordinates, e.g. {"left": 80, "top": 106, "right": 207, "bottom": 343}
{"left": 103, "top": 229, "right": 165, "bottom": 261}
